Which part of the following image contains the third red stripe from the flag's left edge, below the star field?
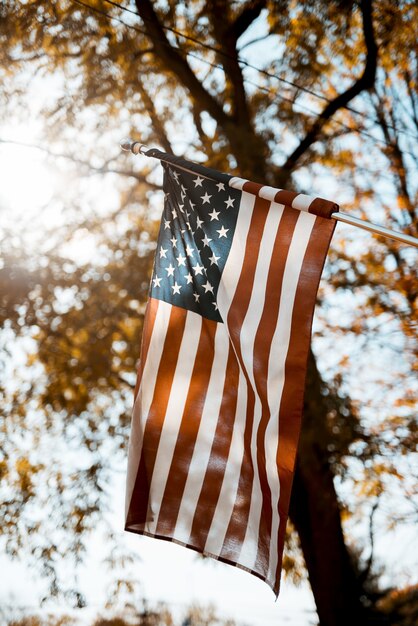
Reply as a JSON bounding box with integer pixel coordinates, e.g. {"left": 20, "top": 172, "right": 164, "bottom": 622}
{"left": 156, "top": 318, "right": 219, "bottom": 535}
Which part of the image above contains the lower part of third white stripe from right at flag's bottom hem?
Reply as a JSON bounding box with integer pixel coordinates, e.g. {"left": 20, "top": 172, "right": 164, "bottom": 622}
{"left": 204, "top": 371, "right": 247, "bottom": 556}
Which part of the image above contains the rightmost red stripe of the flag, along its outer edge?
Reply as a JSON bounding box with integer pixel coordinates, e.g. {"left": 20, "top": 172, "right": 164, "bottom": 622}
{"left": 274, "top": 217, "right": 335, "bottom": 593}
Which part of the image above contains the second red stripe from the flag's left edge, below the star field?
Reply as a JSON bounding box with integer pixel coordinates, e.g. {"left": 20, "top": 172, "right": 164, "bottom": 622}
{"left": 126, "top": 307, "right": 187, "bottom": 526}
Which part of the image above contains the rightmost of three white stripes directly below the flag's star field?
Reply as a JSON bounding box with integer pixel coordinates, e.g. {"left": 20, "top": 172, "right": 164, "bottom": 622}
{"left": 173, "top": 324, "right": 229, "bottom": 543}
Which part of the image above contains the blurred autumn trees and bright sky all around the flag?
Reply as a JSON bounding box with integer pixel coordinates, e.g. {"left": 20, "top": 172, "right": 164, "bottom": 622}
{"left": 0, "top": 0, "right": 418, "bottom": 626}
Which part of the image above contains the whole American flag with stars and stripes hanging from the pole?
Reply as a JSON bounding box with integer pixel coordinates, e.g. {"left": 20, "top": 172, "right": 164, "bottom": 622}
{"left": 125, "top": 151, "right": 338, "bottom": 594}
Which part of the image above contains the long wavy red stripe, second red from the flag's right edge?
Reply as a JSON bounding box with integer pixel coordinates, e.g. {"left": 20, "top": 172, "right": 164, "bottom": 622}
{"left": 254, "top": 207, "right": 300, "bottom": 573}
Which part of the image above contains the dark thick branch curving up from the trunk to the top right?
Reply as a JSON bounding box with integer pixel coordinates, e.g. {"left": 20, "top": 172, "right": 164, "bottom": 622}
{"left": 279, "top": 0, "right": 378, "bottom": 183}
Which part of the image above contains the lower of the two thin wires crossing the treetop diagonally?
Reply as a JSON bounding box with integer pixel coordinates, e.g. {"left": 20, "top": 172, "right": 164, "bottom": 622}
{"left": 72, "top": 0, "right": 416, "bottom": 158}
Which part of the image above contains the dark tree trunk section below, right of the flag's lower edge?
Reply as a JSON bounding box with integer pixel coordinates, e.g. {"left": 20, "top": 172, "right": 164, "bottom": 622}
{"left": 290, "top": 355, "right": 369, "bottom": 626}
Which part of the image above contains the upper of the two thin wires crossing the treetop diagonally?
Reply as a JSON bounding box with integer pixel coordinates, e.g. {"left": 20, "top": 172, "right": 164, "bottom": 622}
{"left": 104, "top": 0, "right": 418, "bottom": 140}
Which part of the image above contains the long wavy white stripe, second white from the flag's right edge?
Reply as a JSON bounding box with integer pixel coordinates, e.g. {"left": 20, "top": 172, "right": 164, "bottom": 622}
{"left": 235, "top": 203, "right": 284, "bottom": 569}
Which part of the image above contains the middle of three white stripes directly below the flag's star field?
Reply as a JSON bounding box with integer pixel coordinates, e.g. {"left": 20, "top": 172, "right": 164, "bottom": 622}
{"left": 145, "top": 311, "right": 202, "bottom": 534}
